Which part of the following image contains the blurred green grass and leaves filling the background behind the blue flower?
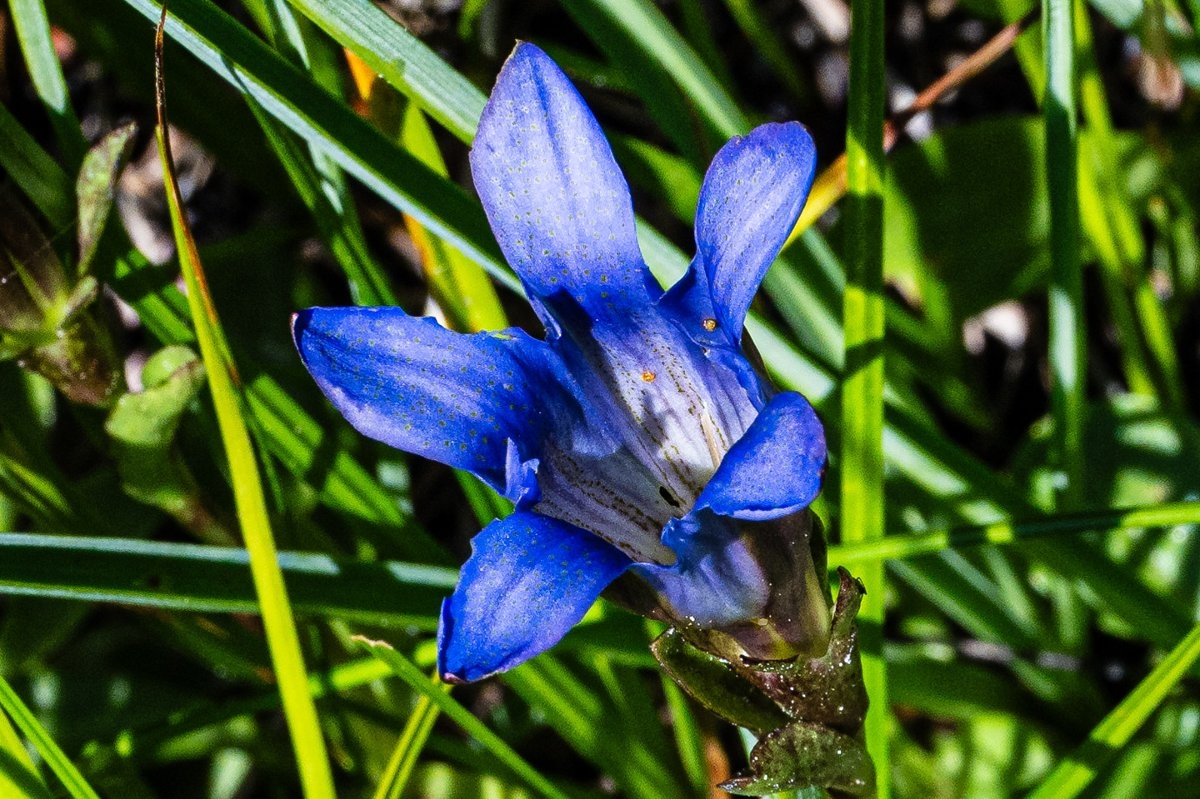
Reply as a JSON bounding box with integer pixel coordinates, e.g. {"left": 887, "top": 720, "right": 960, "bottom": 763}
{"left": 0, "top": 0, "right": 1200, "bottom": 799}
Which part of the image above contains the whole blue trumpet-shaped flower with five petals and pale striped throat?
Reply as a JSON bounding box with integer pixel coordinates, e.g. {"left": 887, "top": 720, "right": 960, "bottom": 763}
{"left": 293, "top": 44, "right": 829, "bottom": 680}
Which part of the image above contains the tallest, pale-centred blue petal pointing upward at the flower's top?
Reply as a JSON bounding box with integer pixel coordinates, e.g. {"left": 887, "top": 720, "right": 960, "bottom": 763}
{"left": 470, "top": 43, "right": 652, "bottom": 331}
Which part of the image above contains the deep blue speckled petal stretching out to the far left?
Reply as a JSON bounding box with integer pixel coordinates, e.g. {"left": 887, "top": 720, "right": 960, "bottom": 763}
{"left": 292, "top": 307, "right": 571, "bottom": 491}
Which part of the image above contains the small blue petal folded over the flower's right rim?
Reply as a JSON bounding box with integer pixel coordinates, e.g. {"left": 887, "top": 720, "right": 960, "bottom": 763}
{"left": 696, "top": 391, "right": 826, "bottom": 520}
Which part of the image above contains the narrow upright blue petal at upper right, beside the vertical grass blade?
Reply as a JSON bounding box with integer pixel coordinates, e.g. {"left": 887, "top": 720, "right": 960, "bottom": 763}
{"left": 671, "top": 122, "right": 816, "bottom": 342}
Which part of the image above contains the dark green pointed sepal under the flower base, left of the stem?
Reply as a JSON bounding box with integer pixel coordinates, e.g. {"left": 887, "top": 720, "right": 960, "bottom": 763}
{"left": 650, "top": 627, "right": 788, "bottom": 733}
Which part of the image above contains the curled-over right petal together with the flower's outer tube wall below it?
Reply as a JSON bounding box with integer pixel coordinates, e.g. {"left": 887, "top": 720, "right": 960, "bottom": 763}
{"left": 634, "top": 392, "right": 828, "bottom": 659}
